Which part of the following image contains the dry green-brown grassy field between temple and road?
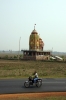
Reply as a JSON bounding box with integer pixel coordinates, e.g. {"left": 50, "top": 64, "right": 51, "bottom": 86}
{"left": 0, "top": 60, "right": 66, "bottom": 78}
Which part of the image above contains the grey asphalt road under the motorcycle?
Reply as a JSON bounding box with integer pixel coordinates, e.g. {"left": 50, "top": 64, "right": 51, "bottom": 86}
{"left": 0, "top": 78, "right": 66, "bottom": 94}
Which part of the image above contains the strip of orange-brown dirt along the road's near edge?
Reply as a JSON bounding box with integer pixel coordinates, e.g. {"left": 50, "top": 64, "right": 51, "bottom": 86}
{"left": 0, "top": 92, "right": 66, "bottom": 99}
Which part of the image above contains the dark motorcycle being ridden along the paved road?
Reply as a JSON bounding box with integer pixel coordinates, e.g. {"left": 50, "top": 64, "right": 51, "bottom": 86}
{"left": 24, "top": 77, "right": 42, "bottom": 88}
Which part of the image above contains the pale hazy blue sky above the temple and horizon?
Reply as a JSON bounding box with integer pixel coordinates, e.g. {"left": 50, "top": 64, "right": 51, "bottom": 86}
{"left": 0, "top": 0, "right": 66, "bottom": 52}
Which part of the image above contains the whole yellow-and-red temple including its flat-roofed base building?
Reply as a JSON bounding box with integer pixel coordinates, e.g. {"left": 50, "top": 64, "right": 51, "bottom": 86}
{"left": 22, "top": 24, "right": 50, "bottom": 60}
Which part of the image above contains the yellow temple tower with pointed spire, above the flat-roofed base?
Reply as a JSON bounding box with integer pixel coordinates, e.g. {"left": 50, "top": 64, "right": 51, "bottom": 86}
{"left": 29, "top": 24, "right": 44, "bottom": 51}
